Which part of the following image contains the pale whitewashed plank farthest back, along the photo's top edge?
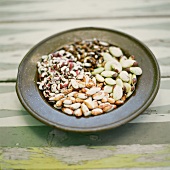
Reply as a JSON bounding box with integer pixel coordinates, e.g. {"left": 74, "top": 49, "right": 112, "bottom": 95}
{"left": 0, "top": 0, "right": 170, "bottom": 22}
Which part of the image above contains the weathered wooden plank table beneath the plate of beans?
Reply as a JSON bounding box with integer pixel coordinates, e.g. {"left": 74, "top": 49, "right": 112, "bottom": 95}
{"left": 0, "top": 0, "right": 170, "bottom": 170}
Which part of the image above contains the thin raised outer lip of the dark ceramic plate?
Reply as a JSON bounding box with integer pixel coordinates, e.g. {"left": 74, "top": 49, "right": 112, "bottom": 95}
{"left": 16, "top": 27, "right": 160, "bottom": 132}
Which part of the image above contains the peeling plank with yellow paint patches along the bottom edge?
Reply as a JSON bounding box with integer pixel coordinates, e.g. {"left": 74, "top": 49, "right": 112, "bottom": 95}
{"left": 0, "top": 145, "right": 170, "bottom": 170}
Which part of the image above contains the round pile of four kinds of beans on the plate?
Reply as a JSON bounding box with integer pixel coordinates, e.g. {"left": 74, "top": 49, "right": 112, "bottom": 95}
{"left": 37, "top": 38, "right": 142, "bottom": 117}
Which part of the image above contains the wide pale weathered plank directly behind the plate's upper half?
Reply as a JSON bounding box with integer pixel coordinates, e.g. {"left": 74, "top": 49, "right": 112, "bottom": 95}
{"left": 0, "top": 18, "right": 170, "bottom": 81}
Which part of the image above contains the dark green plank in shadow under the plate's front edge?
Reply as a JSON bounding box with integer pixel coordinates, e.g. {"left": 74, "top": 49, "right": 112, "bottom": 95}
{"left": 0, "top": 122, "right": 170, "bottom": 147}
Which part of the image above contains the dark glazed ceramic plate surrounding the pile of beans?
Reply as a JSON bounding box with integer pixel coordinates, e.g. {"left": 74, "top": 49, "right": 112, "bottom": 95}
{"left": 16, "top": 27, "right": 160, "bottom": 132}
